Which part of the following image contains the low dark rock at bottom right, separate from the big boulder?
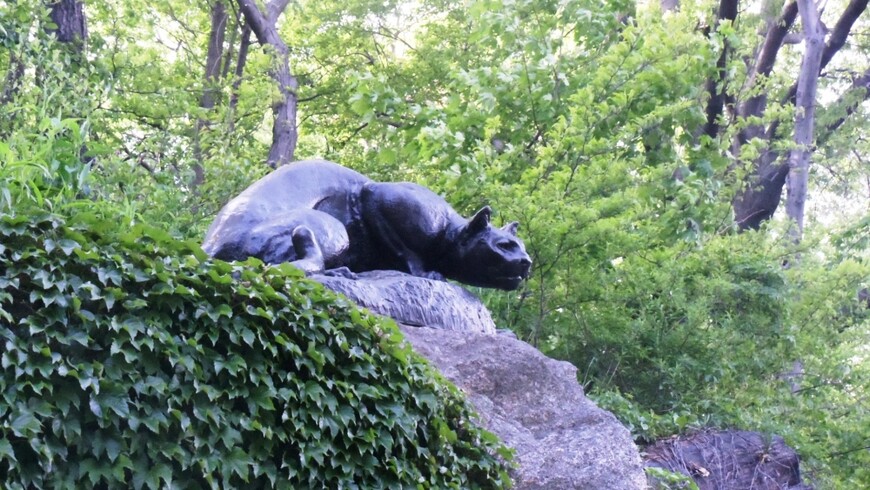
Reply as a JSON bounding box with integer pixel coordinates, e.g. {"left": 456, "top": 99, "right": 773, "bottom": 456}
{"left": 645, "top": 430, "right": 811, "bottom": 490}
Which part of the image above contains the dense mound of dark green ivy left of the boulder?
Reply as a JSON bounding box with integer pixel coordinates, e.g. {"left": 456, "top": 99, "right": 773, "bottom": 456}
{"left": 0, "top": 212, "right": 509, "bottom": 489}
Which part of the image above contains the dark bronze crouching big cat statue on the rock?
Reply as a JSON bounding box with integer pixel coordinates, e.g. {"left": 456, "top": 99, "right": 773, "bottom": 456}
{"left": 203, "top": 160, "right": 532, "bottom": 290}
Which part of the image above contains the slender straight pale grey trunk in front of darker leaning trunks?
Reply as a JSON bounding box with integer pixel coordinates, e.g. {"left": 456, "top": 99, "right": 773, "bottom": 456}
{"left": 785, "top": 0, "right": 825, "bottom": 241}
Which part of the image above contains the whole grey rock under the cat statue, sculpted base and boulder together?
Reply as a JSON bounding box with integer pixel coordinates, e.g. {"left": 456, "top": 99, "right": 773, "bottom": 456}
{"left": 311, "top": 271, "right": 646, "bottom": 490}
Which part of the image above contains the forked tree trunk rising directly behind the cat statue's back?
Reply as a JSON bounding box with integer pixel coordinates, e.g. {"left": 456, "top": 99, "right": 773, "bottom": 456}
{"left": 238, "top": 0, "right": 299, "bottom": 168}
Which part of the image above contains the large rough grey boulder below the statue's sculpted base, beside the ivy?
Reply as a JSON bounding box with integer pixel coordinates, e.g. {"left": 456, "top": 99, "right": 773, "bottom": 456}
{"left": 402, "top": 326, "right": 646, "bottom": 490}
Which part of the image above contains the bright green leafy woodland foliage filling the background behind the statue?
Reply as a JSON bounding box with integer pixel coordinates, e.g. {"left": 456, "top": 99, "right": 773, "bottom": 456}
{"left": 0, "top": 0, "right": 870, "bottom": 488}
